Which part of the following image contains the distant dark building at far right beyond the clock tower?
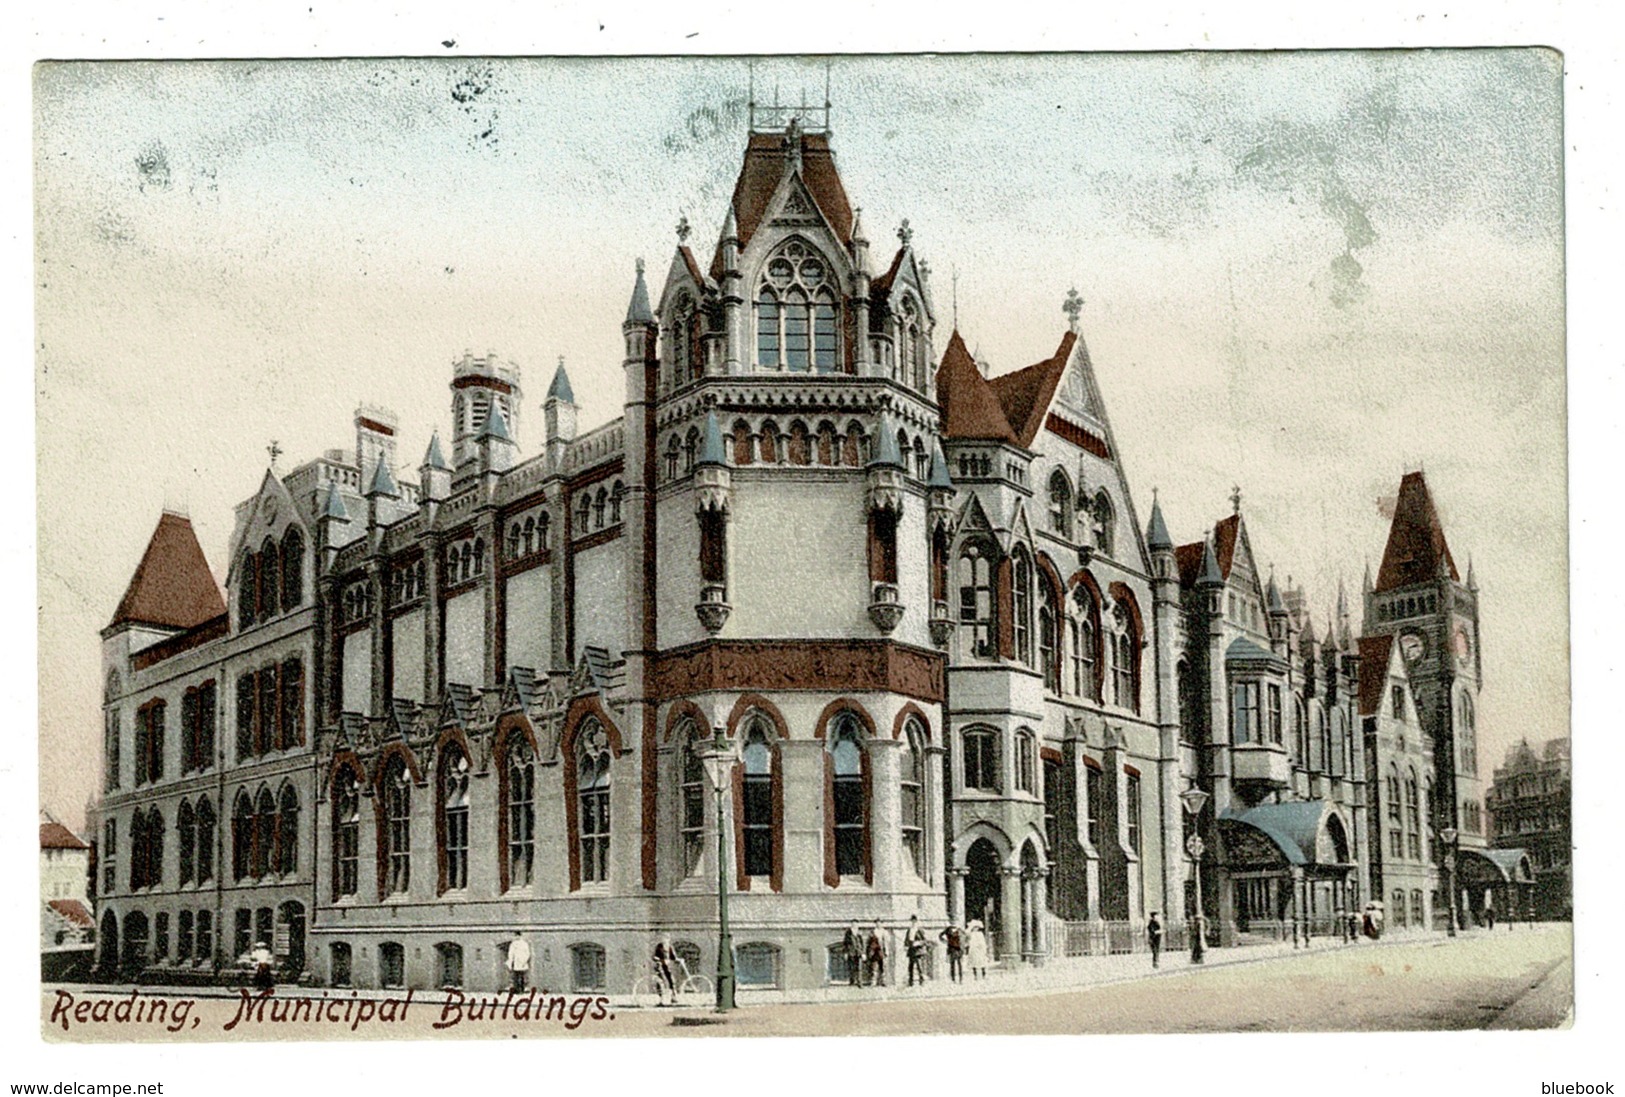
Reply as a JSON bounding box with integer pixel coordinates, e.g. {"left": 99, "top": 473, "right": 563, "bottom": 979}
{"left": 1489, "top": 736, "right": 1575, "bottom": 918}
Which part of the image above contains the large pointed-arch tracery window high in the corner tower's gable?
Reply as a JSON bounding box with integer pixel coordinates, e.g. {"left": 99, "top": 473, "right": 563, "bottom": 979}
{"left": 756, "top": 241, "right": 840, "bottom": 374}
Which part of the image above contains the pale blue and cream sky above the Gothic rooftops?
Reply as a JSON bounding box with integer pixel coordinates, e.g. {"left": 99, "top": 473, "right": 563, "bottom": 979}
{"left": 36, "top": 50, "right": 1568, "bottom": 816}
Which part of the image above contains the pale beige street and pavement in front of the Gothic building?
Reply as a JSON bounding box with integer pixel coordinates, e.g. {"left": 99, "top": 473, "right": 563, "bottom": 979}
{"left": 42, "top": 925, "right": 1573, "bottom": 1042}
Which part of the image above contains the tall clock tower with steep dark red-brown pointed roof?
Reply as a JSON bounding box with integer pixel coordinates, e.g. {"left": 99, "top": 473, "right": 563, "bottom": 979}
{"left": 1363, "top": 473, "right": 1489, "bottom": 848}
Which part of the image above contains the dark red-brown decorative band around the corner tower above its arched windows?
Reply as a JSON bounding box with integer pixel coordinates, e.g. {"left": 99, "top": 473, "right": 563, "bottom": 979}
{"left": 648, "top": 640, "right": 947, "bottom": 704}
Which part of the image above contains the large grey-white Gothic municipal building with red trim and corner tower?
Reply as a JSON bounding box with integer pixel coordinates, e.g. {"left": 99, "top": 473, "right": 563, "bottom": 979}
{"left": 88, "top": 109, "right": 1514, "bottom": 990}
